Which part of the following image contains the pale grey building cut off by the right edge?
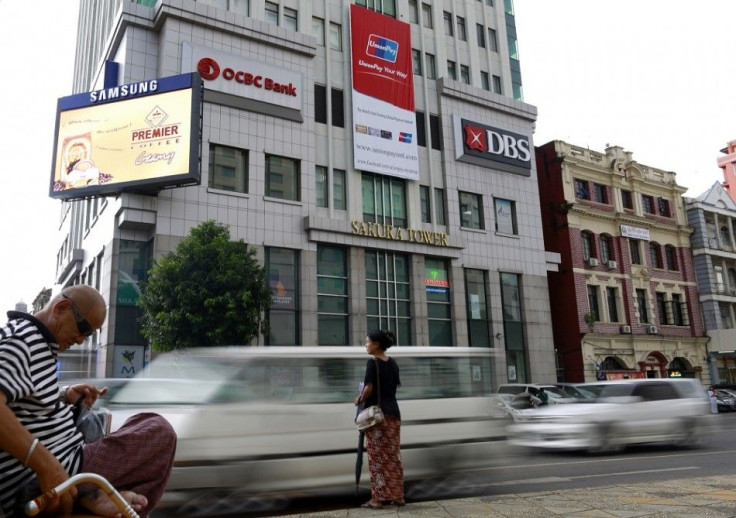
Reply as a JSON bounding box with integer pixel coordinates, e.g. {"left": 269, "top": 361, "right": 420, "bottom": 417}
{"left": 685, "top": 180, "right": 736, "bottom": 384}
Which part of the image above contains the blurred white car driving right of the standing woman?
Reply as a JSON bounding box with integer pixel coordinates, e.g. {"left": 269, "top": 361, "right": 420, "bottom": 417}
{"left": 508, "top": 378, "right": 711, "bottom": 451}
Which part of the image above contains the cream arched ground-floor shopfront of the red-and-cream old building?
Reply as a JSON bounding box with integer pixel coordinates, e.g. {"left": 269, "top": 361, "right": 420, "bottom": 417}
{"left": 581, "top": 334, "right": 711, "bottom": 386}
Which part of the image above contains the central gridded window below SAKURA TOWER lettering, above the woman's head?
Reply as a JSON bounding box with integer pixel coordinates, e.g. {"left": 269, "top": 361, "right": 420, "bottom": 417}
{"left": 365, "top": 250, "right": 412, "bottom": 345}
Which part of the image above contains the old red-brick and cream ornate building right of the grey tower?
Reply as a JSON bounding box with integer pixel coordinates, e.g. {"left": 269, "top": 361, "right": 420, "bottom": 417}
{"left": 536, "top": 141, "right": 709, "bottom": 383}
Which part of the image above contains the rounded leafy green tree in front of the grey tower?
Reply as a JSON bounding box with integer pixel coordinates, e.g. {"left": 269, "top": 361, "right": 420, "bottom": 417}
{"left": 140, "top": 220, "right": 271, "bottom": 351}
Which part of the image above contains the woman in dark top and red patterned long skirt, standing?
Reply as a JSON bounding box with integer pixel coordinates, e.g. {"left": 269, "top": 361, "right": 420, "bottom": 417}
{"left": 355, "top": 329, "right": 404, "bottom": 509}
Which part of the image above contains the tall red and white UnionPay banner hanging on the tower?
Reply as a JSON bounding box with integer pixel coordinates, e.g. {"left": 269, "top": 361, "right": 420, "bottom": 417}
{"left": 350, "top": 4, "right": 419, "bottom": 180}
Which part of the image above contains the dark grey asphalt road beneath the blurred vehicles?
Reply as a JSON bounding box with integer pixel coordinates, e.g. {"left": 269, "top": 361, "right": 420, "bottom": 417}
{"left": 155, "top": 413, "right": 736, "bottom": 518}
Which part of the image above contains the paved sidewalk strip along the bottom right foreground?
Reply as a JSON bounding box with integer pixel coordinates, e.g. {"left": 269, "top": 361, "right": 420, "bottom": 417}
{"left": 291, "top": 474, "right": 736, "bottom": 518}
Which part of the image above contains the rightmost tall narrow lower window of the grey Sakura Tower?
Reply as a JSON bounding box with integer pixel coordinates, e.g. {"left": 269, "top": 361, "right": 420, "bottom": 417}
{"left": 500, "top": 272, "right": 528, "bottom": 383}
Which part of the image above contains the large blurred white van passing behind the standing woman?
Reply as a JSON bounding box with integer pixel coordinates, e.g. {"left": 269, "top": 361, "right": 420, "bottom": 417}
{"left": 107, "top": 347, "right": 505, "bottom": 514}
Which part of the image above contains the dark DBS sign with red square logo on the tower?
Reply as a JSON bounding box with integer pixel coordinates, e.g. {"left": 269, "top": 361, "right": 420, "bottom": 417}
{"left": 454, "top": 116, "right": 533, "bottom": 176}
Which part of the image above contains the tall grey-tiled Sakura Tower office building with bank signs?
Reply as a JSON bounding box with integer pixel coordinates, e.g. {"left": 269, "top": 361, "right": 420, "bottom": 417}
{"left": 57, "top": 0, "right": 556, "bottom": 383}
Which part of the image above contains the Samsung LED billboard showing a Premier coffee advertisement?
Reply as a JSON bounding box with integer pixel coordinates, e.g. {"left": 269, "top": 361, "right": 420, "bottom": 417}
{"left": 49, "top": 73, "right": 202, "bottom": 199}
